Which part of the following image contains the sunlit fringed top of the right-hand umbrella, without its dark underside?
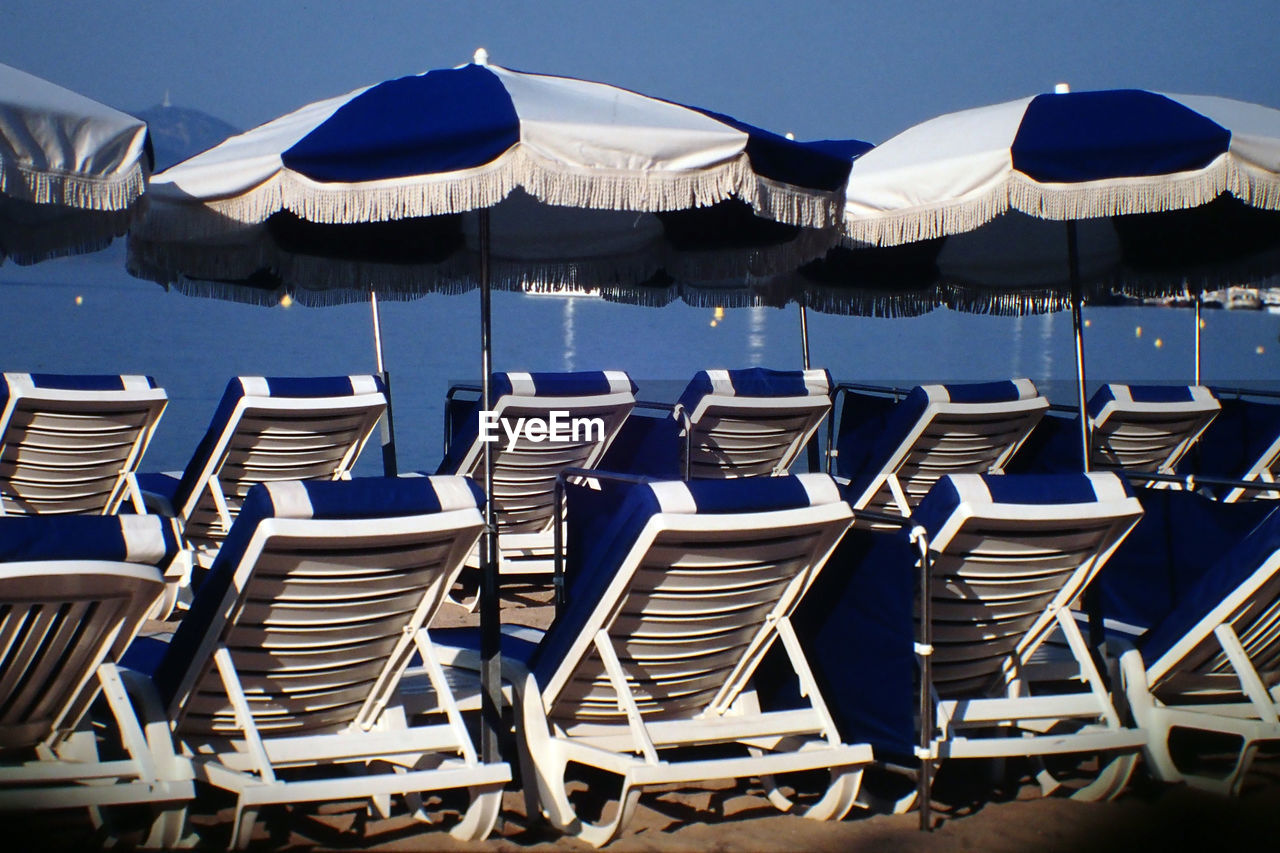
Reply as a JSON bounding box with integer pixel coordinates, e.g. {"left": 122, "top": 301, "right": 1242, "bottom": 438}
{"left": 845, "top": 90, "right": 1280, "bottom": 246}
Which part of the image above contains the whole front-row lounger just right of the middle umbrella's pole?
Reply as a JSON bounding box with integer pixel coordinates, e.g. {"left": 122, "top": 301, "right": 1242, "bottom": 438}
{"left": 433, "top": 474, "right": 872, "bottom": 845}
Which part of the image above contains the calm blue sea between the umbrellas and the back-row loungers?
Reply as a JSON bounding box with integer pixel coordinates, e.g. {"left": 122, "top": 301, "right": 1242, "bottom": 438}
{"left": 0, "top": 245, "right": 1280, "bottom": 474}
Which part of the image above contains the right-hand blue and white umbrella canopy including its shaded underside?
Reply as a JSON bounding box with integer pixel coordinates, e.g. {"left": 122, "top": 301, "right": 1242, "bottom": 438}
{"left": 845, "top": 90, "right": 1280, "bottom": 310}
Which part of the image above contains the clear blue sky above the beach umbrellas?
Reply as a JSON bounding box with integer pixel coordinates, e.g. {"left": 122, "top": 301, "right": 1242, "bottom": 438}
{"left": 0, "top": 0, "right": 1280, "bottom": 142}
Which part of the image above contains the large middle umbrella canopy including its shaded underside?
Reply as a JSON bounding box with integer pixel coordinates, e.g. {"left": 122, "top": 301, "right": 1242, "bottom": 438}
{"left": 129, "top": 49, "right": 869, "bottom": 304}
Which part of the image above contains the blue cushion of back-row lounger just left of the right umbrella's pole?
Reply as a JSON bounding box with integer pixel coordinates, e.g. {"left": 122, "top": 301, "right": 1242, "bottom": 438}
{"left": 836, "top": 380, "right": 1038, "bottom": 498}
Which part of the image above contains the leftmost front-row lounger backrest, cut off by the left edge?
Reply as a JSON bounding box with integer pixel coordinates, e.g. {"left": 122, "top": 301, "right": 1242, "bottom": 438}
{"left": 0, "top": 515, "right": 177, "bottom": 748}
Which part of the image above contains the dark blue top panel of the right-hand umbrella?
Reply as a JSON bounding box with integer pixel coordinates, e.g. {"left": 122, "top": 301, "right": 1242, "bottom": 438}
{"left": 1010, "top": 90, "right": 1231, "bottom": 183}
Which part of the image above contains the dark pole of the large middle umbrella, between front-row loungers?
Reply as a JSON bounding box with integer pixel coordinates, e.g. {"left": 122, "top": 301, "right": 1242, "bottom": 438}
{"left": 479, "top": 209, "right": 502, "bottom": 763}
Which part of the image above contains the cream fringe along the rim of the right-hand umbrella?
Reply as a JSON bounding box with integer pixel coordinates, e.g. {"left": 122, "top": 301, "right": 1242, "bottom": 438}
{"left": 842, "top": 152, "right": 1280, "bottom": 248}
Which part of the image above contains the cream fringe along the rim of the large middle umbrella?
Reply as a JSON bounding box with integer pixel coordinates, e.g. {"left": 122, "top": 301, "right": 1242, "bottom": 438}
{"left": 142, "top": 145, "right": 844, "bottom": 240}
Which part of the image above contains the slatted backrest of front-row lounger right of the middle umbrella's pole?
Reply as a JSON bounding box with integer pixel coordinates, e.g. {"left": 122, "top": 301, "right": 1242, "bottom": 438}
{"left": 531, "top": 474, "right": 851, "bottom": 722}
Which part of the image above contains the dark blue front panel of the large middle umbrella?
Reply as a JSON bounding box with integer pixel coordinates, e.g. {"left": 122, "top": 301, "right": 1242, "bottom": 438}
{"left": 280, "top": 65, "right": 520, "bottom": 183}
